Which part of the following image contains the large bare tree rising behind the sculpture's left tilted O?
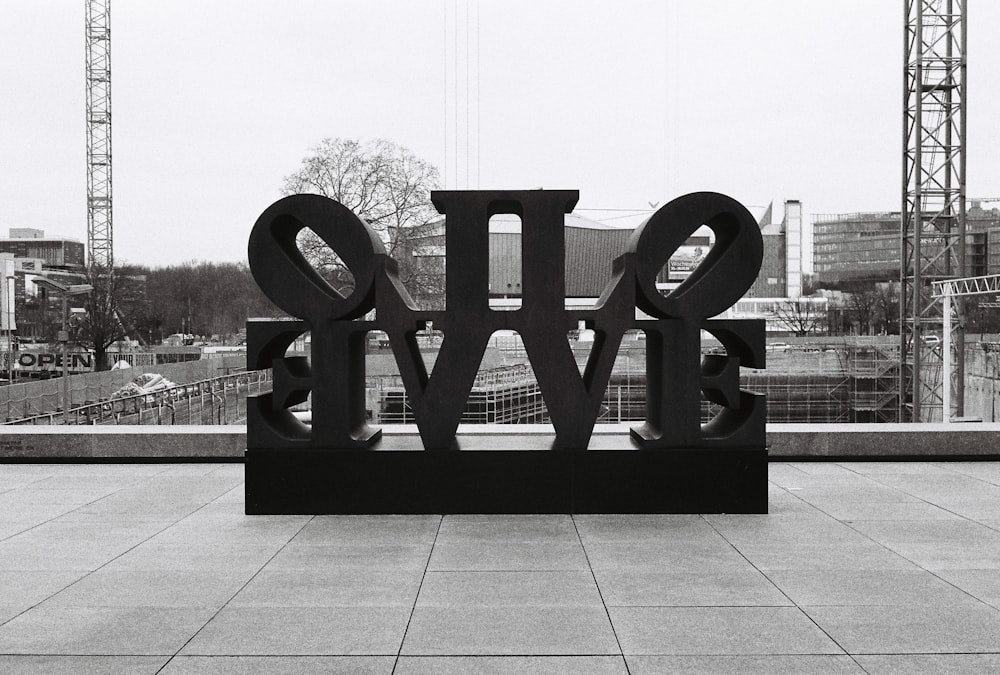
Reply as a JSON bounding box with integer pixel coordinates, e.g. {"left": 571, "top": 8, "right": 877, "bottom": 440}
{"left": 283, "top": 138, "right": 444, "bottom": 298}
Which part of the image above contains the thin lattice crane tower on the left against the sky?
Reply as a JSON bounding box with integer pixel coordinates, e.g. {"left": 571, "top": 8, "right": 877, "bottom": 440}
{"left": 86, "top": 0, "right": 114, "bottom": 270}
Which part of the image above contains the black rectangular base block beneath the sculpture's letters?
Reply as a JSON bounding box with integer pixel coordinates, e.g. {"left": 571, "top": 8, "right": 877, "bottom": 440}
{"left": 246, "top": 447, "right": 767, "bottom": 515}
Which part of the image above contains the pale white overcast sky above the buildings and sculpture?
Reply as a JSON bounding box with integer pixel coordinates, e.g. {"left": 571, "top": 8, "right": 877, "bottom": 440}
{"left": 0, "top": 0, "right": 1000, "bottom": 266}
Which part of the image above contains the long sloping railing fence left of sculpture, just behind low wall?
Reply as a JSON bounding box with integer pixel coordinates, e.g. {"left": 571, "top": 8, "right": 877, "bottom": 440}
{"left": 6, "top": 370, "right": 271, "bottom": 425}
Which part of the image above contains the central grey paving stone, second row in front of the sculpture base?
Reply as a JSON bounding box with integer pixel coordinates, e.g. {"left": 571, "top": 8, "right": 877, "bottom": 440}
{"left": 428, "top": 541, "right": 587, "bottom": 571}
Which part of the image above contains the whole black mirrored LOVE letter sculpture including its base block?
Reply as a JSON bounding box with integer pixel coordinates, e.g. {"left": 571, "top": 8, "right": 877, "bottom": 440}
{"left": 246, "top": 190, "right": 767, "bottom": 513}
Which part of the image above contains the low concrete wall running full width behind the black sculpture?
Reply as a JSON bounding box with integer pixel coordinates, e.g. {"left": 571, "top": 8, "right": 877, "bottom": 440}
{"left": 0, "top": 423, "right": 1000, "bottom": 461}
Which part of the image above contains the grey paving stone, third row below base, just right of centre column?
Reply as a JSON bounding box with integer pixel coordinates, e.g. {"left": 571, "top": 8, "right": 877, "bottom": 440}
{"left": 595, "top": 565, "right": 792, "bottom": 607}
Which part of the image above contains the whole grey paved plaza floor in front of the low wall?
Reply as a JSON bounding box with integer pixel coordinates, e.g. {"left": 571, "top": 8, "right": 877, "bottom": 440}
{"left": 0, "top": 462, "right": 1000, "bottom": 674}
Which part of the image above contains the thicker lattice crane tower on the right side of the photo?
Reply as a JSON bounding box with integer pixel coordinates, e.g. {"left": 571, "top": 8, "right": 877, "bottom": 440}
{"left": 899, "top": 0, "right": 967, "bottom": 422}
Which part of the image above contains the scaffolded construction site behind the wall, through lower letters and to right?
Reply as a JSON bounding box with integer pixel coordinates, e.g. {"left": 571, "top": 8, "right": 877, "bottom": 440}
{"left": 367, "top": 334, "right": 1000, "bottom": 424}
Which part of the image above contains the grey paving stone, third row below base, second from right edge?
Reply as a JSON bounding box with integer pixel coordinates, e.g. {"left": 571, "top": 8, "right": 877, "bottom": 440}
{"left": 767, "top": 569, "right": 972, "bottom": 606}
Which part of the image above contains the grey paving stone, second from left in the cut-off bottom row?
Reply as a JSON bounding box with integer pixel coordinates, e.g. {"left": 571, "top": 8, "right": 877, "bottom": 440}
{"left": 160, "top": 656, "right": 396, "bottom": 675}
